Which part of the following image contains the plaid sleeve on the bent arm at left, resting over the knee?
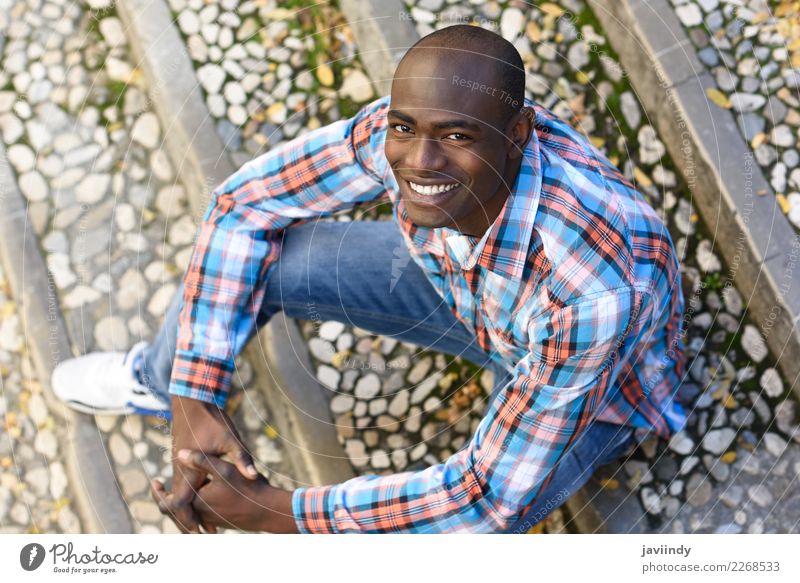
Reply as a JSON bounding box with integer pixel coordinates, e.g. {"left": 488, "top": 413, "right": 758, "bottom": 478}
{"left": 169, "top": 96, "right": 389, "bottom": 407}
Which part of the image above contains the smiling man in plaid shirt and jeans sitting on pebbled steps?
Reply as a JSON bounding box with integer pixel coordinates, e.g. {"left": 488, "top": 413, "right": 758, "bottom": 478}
{"left": 53, "top": 25, "right": 685, "bottom": 532}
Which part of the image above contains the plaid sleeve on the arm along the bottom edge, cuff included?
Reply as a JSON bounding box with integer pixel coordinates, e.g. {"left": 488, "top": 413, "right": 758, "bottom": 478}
{"left": 292, "top": 290, "right": 634, "bottom": 533}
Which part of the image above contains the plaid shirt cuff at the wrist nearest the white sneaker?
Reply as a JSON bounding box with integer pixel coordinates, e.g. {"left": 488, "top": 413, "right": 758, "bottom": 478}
{"left": 169, "top": 351, "right": 234, "bottom": 408}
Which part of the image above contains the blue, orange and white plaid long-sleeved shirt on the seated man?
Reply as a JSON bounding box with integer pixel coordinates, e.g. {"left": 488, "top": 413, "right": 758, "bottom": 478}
{"left": 170, "top": 97, "right": 686, "bottom": 533}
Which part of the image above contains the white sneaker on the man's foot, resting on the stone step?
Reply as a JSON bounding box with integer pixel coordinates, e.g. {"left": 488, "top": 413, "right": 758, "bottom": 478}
{"left": 51, "top": 342, "right": 170, "bottom": 417}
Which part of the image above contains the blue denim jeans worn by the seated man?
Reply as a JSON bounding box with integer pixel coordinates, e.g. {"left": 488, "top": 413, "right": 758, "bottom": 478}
{"left": 143, "top": 221, "right": 633, "bottom": 532}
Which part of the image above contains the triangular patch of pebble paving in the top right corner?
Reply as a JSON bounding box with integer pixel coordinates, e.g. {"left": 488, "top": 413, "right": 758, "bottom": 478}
{"left": 671, "top": 0, "right": 800, "bottom": 229}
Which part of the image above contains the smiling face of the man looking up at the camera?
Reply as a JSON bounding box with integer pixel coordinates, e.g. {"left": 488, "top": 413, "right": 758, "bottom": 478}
{"left": 385, "top": 49, "right": 519, "bottom": 235}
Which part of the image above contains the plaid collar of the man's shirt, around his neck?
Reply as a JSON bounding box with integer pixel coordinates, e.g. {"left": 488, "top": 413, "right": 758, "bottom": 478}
{"left": 445, "top": 108, "right": 542, "bottom": 286}
